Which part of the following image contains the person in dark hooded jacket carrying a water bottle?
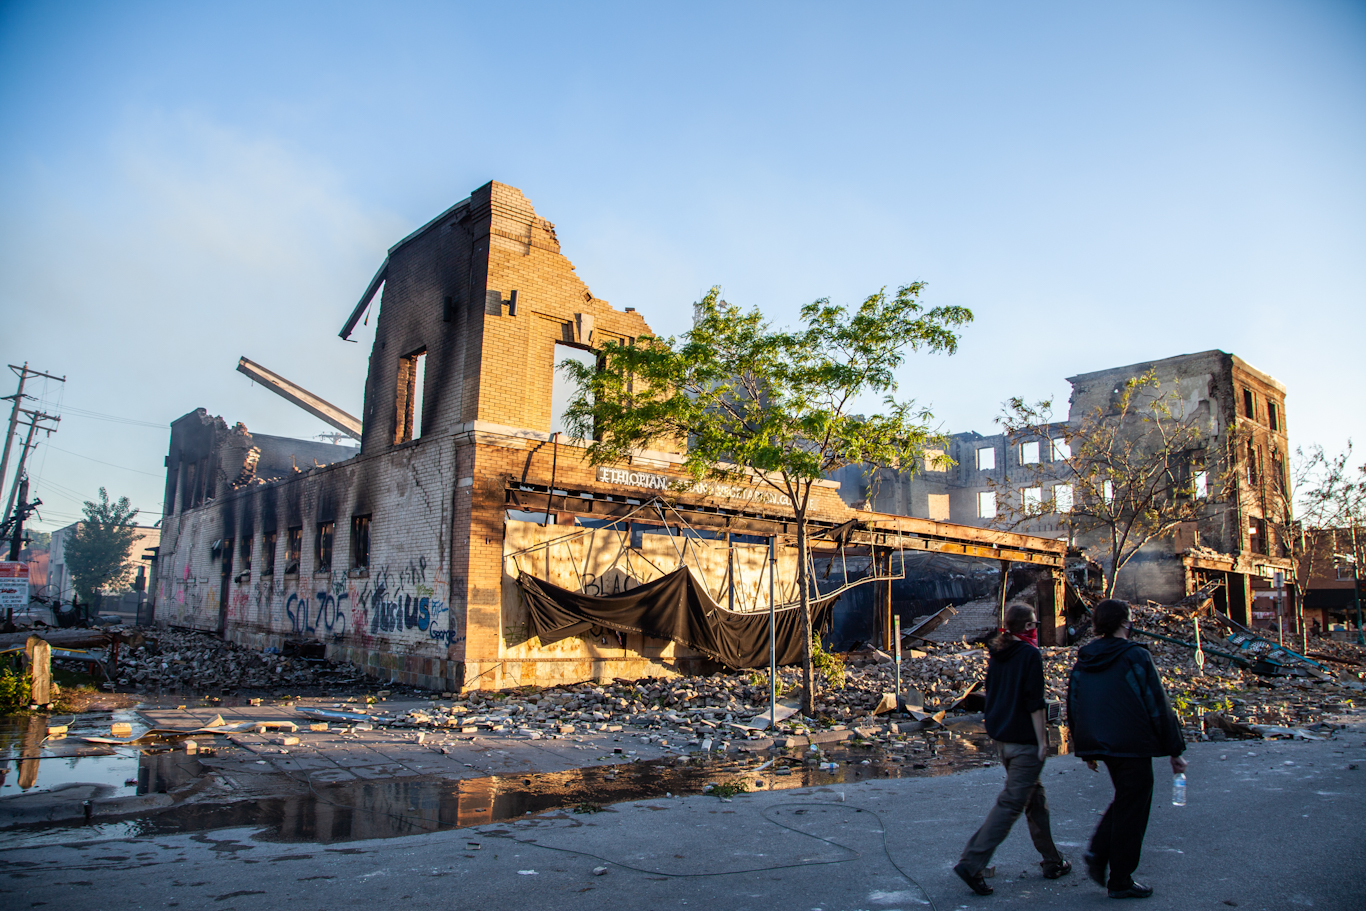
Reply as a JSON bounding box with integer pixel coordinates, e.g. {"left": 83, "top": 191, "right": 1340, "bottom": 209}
{"left": 1067, "top": 598, "right": 1186, "bottom": 899}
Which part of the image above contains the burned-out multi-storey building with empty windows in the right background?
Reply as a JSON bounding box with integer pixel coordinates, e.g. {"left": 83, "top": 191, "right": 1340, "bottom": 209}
{"left": 840, "top": 351, "right": 1296, "bottom": 627}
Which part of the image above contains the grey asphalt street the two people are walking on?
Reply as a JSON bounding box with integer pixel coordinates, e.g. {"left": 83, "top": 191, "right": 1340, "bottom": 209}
{"left": 0, "top": 727, "right": 1366, "bottom": 911}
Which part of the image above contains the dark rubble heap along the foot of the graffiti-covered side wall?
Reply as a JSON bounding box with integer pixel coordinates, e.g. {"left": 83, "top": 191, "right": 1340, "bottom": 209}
{"left": 104, "top": 630, "right": 365, "bottom": 692}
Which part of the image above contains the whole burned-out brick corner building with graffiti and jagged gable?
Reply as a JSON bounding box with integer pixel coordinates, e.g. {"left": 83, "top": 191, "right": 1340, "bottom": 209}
{"left": 156, "top": 183, "right": 1065, "bottom": 690}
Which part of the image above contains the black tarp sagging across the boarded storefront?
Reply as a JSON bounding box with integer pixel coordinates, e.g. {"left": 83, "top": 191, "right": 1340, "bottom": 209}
{"left": 518, "top": 567, "right": 836, "bottom": 668}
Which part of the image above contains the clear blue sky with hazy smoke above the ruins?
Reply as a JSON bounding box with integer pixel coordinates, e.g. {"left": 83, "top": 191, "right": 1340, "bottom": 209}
{"left": 0, "top": 0, "right": 1366, "bottom": 529}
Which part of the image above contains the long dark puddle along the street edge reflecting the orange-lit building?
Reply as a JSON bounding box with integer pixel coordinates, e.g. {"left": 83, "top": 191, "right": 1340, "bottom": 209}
{"left": 0, "top": 733, "right": 1027, "bottom": 847}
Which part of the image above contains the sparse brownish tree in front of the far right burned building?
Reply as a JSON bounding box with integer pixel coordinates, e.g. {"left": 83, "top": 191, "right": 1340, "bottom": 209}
{"left": 996, "top": 370, "right": 1223, "bottom": 598}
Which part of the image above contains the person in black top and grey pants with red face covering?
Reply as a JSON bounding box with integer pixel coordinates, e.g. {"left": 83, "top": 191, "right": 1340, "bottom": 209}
{"left": 953, "top": 604, "right": 1072, "bottom": 895}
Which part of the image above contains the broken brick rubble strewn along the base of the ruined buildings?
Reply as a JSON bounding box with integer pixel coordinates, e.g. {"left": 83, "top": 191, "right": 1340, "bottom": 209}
{"left": 85, "top": 609, "right": 1366, "bottom": 748}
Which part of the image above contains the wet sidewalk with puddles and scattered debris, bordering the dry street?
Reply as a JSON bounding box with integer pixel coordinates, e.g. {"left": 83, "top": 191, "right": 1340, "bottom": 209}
{"left": 0, "top": 703, "right": 1027, "bottom": 848}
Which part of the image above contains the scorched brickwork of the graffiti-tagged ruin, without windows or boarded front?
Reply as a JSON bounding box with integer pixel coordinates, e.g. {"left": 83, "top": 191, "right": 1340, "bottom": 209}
{"left": 157, "top": 177, "right": 1061, "bottom": 690}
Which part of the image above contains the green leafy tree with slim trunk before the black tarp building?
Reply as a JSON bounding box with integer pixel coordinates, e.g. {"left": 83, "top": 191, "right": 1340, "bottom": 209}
{"left": 560, "top": 283, "right": 973, "bottom": 716}
